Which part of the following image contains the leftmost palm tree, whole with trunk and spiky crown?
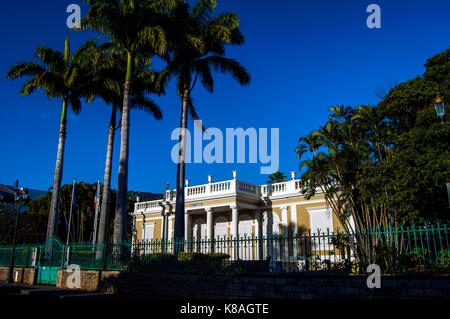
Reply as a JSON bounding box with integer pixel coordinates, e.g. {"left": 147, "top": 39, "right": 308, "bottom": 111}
{"left": 6, "top": 36, "right": 90, "bottom": 239}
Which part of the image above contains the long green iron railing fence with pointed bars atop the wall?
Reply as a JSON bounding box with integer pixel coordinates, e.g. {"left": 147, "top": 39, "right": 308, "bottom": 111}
{"left": 0, "top": 224, "right": 450, "bottom": 273}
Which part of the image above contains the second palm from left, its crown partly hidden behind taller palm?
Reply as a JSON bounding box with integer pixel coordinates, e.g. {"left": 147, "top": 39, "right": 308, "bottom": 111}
{"left": 81, "top": 41, "right": 164, "bottom": 243}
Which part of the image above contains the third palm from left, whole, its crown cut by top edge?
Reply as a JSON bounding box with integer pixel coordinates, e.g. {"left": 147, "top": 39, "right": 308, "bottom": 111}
{"left": 81, "top": 0, "right": 177, "bottom": 242}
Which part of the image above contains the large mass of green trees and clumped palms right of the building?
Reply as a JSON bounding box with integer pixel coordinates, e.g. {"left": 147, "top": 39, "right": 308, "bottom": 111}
{"left": 296, "top": 49, "right": 450, "bottom": 263}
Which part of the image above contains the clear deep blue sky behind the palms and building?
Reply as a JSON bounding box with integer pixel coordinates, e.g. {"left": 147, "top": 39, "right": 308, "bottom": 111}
{"left": 0, "top": 0, "right": 450, "bottom": 192}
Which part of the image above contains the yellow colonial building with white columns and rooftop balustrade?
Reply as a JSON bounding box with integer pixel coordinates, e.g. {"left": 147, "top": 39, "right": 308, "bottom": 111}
{"left": 132, "top": 171, "right": 348, "bottom": 259}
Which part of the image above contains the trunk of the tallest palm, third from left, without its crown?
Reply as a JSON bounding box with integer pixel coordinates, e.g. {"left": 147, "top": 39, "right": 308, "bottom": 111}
{"left": 113, "top": 53, "right": 133, "bottom": 242}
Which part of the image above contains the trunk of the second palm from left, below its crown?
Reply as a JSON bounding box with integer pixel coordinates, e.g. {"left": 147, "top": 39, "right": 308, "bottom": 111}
{"left": 98, "top": 104, "right": 117, "bottom": 243}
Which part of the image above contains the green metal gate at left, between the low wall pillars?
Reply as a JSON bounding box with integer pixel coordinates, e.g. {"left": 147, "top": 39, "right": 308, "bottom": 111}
{"left": 37, "top": 239, "right": 66, "bottom": 285}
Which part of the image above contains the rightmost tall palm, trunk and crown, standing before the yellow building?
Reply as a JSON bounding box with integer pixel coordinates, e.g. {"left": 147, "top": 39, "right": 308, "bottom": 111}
{"left": 159, "top": 0, "right": 250, "bottom": 239}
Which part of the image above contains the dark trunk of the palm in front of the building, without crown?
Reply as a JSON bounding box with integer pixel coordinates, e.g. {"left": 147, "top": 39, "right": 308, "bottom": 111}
{"left": 174, "top": 90, "right": 189, "bottom": 244}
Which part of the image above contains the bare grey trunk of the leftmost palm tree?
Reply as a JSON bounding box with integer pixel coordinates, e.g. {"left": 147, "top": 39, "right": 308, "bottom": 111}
{"left": 47, "top": 100, "right": 67, "bottom": 240}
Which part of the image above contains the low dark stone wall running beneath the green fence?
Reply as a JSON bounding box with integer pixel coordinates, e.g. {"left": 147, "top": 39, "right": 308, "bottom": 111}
{"left": 57, "top": 270, "right": 450, "bottom": 299}
